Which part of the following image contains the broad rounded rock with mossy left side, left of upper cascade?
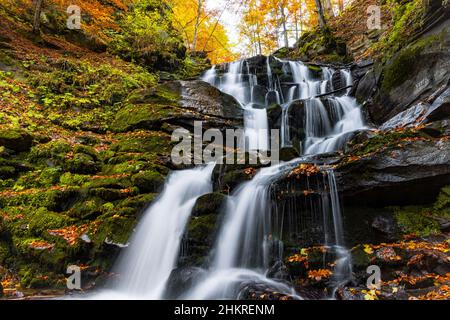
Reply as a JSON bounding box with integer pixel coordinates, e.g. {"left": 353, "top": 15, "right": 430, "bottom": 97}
{"left": 114, "top": 81, "right": 243, "bottom": 132}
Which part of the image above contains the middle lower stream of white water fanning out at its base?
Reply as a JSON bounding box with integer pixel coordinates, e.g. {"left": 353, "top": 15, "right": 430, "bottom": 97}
{"left": 183, "top": 164, "right": 300, "bottom": 300}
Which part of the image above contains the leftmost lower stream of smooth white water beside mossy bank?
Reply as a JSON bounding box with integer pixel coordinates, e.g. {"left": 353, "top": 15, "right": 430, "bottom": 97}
{"left": 94, "top": 164, "right": 214, "bottom": 299}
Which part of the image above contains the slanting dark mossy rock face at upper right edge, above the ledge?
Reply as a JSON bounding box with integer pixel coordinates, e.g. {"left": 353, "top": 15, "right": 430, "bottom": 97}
{"left": 364, "top": 20, "right": 450, "bottom": 124}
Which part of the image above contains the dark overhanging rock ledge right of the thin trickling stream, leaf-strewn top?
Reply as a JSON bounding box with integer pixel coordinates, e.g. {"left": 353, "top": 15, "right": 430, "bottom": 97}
{"left": 337, "top": 138, "right": 450, "bottom": 206}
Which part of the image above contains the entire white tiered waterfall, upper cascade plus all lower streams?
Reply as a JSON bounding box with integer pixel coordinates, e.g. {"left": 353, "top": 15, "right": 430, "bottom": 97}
{"left": 96, "top": 57, "right": 365, "bottom": 299}
